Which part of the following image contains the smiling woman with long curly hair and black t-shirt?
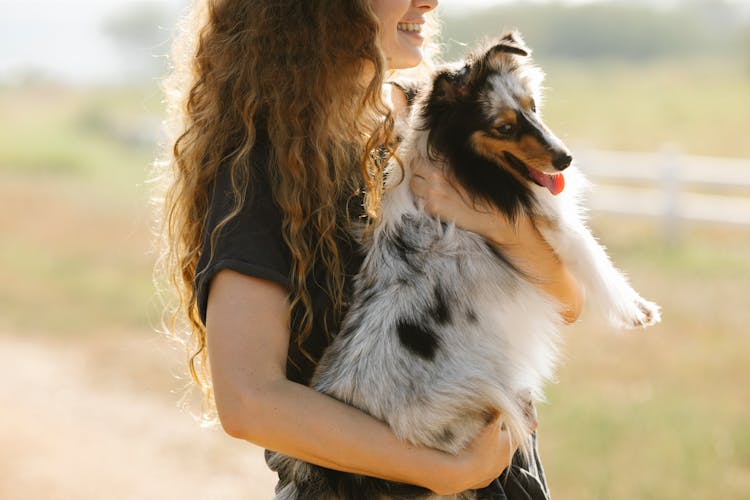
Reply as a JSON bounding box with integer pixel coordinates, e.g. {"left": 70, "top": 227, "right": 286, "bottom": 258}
{"left": 156, "top": 0, "right": 581, "bottom": 498}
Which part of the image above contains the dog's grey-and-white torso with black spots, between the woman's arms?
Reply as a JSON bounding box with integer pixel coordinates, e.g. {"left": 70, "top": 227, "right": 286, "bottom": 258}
{"left": 314, "top": 168, "right": 561, "bottom": 452}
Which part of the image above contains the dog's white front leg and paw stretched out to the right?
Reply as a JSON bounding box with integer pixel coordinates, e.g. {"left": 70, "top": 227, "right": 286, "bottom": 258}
{"left": 539, "top": 221, "right": 661, "bottom": 328}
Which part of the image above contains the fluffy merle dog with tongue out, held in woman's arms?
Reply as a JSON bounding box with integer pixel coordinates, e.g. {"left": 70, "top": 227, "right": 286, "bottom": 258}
{"left": 269, "top": 32, "right": 660, "bottom": 500}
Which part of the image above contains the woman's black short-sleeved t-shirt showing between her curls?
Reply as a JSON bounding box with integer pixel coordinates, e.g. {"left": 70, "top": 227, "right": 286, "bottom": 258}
{"left": 195, "top": 134, "right": 362, "bottom": 385}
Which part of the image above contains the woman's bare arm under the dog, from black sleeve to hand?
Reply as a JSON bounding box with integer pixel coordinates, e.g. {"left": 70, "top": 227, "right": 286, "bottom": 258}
{"left": 206, "top": 270, "right": 515, "bottom": 494}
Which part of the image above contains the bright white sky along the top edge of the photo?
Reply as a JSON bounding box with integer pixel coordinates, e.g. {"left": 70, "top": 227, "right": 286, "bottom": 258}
{"left": 0, "top": 0, "right": 750, "bottom": 83}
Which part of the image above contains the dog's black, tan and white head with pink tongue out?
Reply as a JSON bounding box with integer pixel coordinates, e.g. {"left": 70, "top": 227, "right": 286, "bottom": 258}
{"left": 420, "top": 32, "right": 572, "bottom": 217}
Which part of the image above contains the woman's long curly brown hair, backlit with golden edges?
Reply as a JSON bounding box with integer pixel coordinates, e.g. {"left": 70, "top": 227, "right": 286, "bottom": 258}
{"left": 156, "top": 0, "right": 440, "bottom": 416}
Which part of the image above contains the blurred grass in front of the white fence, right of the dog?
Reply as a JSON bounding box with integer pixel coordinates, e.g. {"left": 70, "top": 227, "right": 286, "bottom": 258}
{"left": 540, "top": 217, "right": 750, "bottom": 499}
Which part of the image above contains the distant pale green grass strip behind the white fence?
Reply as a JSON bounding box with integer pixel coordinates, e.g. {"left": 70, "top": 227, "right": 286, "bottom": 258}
{"left": 542, "top": 61, "right": 750, "bottom": 157}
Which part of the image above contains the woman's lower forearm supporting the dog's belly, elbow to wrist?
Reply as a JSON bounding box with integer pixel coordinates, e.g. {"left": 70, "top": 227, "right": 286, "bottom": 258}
{"left": 231, "top": 379, "right": 456, "bottom": 490}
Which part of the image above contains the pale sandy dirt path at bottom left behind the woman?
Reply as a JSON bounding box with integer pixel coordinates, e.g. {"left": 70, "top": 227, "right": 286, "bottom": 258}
{"left": 0, "top": 334, "right": 274, "bottom": 500}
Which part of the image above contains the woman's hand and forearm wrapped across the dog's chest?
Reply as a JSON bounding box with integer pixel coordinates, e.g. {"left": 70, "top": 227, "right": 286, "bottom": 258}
{"left": 410, "top": 163, "right": 584, "bottom": 323}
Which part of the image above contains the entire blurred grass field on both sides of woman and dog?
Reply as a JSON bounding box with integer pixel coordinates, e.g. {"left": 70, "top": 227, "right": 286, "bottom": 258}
{"left": 0, "top": 66, "right": 750, "bottom": 500}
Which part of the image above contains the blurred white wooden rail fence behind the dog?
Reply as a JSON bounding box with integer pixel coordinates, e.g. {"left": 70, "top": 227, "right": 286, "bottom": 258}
{"left": 576, "top": 148, "right": 750, "bottom": 239}
